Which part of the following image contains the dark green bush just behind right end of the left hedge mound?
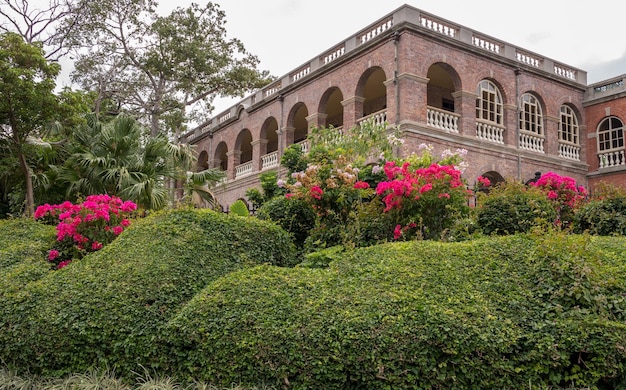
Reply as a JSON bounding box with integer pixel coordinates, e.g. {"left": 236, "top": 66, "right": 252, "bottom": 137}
{"left": 257, "top": 196, "right": 315, "bottom": 248}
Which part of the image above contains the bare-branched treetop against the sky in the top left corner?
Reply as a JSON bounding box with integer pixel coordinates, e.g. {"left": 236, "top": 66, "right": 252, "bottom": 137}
{"left": 0, "top": 0, "right": 83, "bottom": 61}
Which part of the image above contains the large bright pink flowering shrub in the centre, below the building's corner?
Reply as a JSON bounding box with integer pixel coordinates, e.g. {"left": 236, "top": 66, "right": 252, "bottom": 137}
{"left": 376, "top": 161, "right": 469, "bottom": 240}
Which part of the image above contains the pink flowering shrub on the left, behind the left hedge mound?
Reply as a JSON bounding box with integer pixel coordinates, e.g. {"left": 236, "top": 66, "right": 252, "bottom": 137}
{"left": 35, "top": 195, "right": 137, "bottom": 269}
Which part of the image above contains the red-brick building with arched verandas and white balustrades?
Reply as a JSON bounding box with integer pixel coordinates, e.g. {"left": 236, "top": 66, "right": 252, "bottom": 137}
{"left": 178, "top": 5, "right": 626, "bottom": 206}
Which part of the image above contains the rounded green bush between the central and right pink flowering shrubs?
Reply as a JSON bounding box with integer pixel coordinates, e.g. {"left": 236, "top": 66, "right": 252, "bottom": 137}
{"left": 476, "top": 182, "right": 558, "bottom": 235}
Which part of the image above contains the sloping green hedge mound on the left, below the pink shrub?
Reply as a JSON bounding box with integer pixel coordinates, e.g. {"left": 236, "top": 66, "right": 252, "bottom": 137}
{"left": 0, "top": 209, "right": 294, "bottom": 376}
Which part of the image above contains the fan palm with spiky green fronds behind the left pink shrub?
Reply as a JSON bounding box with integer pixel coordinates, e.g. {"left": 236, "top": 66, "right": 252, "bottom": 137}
{"left": 56, "top": 115, "right": 221, "bottom": 209}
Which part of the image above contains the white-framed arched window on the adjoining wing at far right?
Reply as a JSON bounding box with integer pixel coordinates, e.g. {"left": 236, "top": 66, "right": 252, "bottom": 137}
{"left": 598, "top": 117, "right": 626, "bottom": 168}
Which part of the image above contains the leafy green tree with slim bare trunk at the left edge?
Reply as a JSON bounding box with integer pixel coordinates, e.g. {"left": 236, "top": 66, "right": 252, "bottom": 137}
{"left": 0, "top": 33, "right": 60, "bottom": 215}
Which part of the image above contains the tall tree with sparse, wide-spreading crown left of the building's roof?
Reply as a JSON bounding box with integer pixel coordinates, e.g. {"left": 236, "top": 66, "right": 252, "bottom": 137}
{"left": 71, "top": 0, "right": 268, "bottom": 136}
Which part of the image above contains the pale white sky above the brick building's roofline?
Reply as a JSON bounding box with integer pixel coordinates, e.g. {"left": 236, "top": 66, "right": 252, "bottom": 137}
{"left": 63, "top": 0, "right": 626, "bottom": 114}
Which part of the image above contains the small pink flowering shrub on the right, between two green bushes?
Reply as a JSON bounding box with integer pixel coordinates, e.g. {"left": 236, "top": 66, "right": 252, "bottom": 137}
{"left": 530, "top": 172, "right": 587, "bottom": 226}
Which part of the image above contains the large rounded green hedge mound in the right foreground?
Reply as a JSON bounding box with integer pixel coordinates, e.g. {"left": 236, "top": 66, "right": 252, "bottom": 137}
{"left": 167, "top": 235, "right": 626, "bottom": 389}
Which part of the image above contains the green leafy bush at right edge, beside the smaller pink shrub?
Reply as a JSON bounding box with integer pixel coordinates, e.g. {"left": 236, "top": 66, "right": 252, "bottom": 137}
{"left": 573, "top": 185, "right": 626, "bottom": 236}
